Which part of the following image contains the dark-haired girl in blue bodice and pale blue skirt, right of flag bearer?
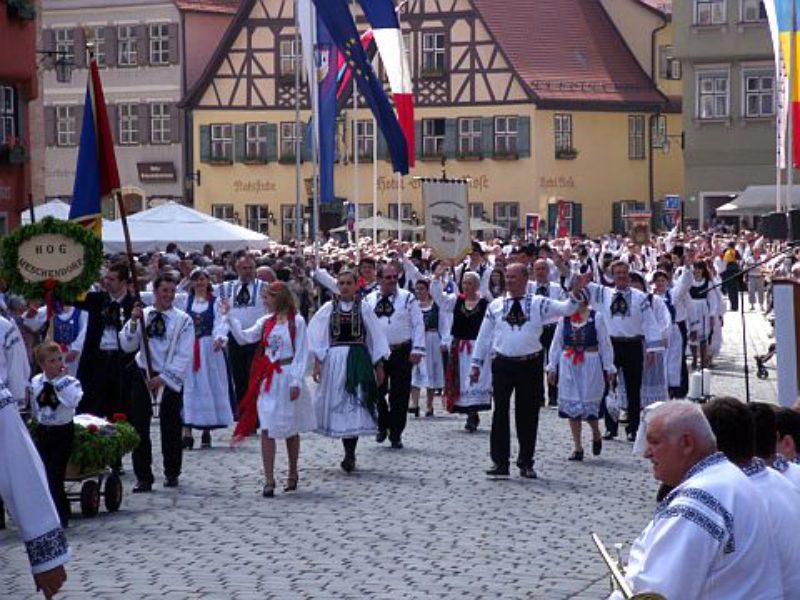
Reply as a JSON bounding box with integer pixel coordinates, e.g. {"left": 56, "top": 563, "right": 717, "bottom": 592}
{"left": 176, "top": 268, "right": 233, "bottom": 450}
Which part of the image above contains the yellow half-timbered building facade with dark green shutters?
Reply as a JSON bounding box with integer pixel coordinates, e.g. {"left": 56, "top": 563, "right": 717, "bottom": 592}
{"left": 184, "top": 0, "right": 683, "bottom": 240}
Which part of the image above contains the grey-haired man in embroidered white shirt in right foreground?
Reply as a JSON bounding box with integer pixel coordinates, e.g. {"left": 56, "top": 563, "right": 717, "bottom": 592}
{"left": 610, "top": 400, "right": 787, "bottom": 600}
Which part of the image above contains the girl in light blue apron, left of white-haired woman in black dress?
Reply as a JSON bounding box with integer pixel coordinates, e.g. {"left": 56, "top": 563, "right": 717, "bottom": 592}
{"left": 408, "top": 279, "right": 447, "bottom": 417}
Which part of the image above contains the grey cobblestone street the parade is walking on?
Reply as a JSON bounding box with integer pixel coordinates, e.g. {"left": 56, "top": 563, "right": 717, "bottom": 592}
{"left": 0, "top": 312, "right": 776, "bottom": 600}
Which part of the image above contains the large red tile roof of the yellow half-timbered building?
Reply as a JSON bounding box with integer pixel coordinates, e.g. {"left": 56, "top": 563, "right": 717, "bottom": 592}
{"left": 473, "top": 0, "right": 667, "bottom": 110}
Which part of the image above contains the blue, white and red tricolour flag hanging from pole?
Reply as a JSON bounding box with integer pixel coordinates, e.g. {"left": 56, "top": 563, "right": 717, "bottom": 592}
{"left": 359, "top": 0, "right": 415, "bottom": 167}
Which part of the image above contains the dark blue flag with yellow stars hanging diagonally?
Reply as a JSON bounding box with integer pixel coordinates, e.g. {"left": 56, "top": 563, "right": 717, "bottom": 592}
{"left": 314, "top": 0, "right": 408, "bottom": 175}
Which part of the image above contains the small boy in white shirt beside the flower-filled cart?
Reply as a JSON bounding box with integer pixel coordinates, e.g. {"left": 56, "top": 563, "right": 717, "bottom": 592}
{"left": 30, "top": 342, "right": 83, "bottom": 527}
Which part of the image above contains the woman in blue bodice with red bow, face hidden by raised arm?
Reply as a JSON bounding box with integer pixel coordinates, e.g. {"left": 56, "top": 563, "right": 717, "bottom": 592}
{"left": 547, "top": 304, "right": 617, "bottom": 461}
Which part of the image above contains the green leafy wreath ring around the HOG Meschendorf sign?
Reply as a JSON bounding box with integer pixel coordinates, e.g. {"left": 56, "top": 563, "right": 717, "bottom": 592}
{"left": 0, "top": 217, "right": 103, "bottom": 302}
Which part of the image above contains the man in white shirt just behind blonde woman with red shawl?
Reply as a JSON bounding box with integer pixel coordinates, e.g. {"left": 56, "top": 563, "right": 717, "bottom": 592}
{"left": 214, "top": 253, "right": 266, "bottom": 416}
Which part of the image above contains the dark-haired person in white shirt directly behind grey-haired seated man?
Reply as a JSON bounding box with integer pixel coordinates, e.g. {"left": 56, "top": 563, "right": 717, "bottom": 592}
{"left": 703, "top": 398, "right": 800, "bottom": 597}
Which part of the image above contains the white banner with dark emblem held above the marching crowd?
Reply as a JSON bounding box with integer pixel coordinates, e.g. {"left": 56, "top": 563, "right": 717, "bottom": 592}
{"left": 422, "top": 179, "right": 472, "bottom": 260}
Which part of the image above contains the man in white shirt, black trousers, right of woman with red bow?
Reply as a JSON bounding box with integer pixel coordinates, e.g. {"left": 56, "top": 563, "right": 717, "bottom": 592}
{"left": 588, "top": 260, "right": 662, "bottom": 442}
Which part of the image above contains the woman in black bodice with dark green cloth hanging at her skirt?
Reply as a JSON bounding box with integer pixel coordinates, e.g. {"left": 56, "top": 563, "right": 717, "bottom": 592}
{"left": 308, "top": 270, "right": 389, "bottom": 473}
